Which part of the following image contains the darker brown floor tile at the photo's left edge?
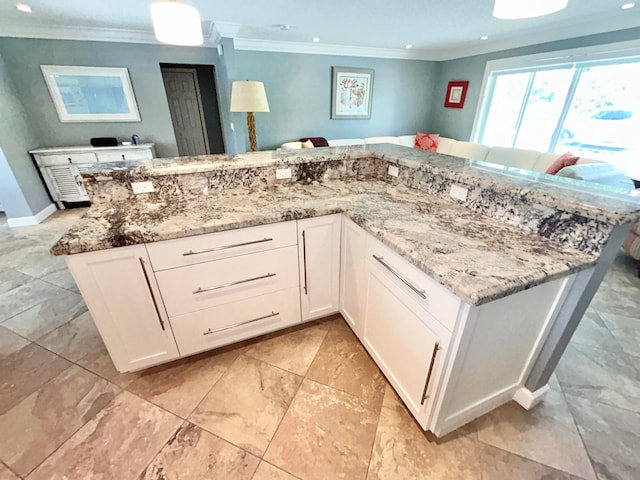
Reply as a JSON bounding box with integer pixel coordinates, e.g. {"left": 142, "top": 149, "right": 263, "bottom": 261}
{"left": 0, "top": 344, "right": 71, "bottom": 415}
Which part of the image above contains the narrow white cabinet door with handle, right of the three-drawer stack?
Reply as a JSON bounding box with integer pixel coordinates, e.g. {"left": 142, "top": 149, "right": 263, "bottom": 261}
{"left": 298, "top": 215, "right": 341, "bottom": 320}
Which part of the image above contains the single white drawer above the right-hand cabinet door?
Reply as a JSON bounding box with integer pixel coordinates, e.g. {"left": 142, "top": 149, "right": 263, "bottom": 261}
{"left": 367, "top": 238, "right": 461, "bottom": 331}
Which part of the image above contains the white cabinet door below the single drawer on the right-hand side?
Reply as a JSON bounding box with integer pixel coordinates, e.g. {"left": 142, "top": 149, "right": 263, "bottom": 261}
{"left": 363, "top": 262, "right": 450, "bottom": 430}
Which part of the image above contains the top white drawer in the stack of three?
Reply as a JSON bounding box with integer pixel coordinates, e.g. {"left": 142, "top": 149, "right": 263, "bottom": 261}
{"left": 147, "top": 221, "right": 297, "bottom": 272}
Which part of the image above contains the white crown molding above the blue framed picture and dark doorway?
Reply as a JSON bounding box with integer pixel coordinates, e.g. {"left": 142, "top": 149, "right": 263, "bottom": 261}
{"left": 0, "top": 24, "right": 222, "bottom": 48}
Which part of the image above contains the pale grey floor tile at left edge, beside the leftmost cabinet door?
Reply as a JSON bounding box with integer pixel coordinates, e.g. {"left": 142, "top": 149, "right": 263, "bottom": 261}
{"left": 2, "top": 285, "right": 87, "bottom": 340}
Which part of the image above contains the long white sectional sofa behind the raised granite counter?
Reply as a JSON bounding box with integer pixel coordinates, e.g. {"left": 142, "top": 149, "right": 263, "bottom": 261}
{"left": 281, "top": 135, "right": 634, "bottom": 189}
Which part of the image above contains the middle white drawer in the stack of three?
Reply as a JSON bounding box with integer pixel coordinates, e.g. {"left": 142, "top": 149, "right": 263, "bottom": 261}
{"left": 156, "top": 246, "right": 298, "bottom": 317}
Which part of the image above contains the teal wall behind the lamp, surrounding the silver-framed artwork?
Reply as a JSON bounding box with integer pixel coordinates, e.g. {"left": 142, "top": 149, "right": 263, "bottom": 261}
{"left": 228, "top": 51, "right": 440, "bottom": 149}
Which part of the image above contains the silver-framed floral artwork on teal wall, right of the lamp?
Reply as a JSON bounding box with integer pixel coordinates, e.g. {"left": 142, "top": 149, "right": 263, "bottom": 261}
{"left": 331, "top": 67, "right": 375, "bottom": 120}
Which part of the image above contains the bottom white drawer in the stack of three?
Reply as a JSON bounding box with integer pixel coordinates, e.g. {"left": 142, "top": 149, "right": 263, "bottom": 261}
{"left": 170, "top": 287, "right": 300, "bottom": 356}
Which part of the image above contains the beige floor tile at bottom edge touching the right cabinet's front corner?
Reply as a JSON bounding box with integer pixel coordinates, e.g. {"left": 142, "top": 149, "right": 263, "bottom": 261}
{"left": 367, "top": 389, "right": 481, "bottom": 480}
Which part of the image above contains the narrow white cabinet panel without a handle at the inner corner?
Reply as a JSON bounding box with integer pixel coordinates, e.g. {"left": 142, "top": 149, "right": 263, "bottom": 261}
{"left": 340, "top": 218, "right": 368, "bottom": 337}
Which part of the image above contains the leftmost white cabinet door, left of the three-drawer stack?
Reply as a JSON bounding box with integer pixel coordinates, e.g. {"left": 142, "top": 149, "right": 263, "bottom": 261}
{"left": 67, "top": 245, "right": 179, "bottom": 372}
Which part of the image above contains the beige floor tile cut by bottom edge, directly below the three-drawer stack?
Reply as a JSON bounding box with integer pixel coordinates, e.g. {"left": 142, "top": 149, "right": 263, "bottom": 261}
{"left": 140, "top": 423, "right": 260, "bottom": 480}
